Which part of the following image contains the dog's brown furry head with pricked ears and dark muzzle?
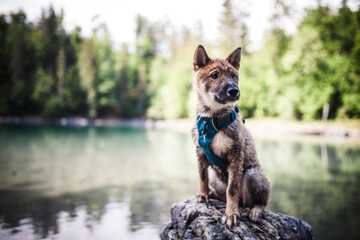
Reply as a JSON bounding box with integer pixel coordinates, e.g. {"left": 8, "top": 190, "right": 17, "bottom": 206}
{"left": 193, "top": 45, "right": 241, "bottom": 111}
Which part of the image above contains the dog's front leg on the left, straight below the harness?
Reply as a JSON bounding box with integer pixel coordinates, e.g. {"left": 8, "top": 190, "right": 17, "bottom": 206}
{"left": 197, "top": 149, "right": 209, "bottom": 203}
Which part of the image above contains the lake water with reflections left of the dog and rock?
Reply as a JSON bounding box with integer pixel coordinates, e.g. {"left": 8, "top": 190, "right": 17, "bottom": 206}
{"left": 0, "top": 127, "right": 197, "bottom": 239}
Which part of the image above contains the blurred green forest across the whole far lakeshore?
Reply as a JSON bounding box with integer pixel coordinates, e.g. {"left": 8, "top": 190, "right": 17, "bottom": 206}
{"left": 0, "top": 0, "right": 360, "bottom": 120}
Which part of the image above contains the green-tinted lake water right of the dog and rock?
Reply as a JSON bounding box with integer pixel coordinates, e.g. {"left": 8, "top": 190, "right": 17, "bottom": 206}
{"left": 257, "top": 137, "right": 360, "bottom": 239}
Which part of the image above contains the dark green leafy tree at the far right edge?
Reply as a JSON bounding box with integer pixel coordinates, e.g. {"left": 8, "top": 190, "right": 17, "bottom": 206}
{"left": 303, "top": 4, "right": 360, "bottom": 118}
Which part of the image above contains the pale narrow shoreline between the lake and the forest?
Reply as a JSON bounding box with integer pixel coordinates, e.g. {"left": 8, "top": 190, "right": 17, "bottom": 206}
{"left": 0, "top": 117, "right": 360, "bottom": 140}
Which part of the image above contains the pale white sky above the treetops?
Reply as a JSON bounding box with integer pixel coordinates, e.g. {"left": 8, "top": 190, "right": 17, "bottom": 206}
{"left": 0, "top": 0, "right": 360, "bottom": 50}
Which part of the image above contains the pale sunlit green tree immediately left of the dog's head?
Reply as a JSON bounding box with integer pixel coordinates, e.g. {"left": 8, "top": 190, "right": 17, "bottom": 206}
{"left": 148, "top": 29, "right": 198, "bottom": 119}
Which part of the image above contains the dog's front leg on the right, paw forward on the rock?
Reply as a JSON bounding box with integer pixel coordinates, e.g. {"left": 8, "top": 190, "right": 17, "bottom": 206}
{"left": 223, "top": 155, "right": 242, "bottom": 228}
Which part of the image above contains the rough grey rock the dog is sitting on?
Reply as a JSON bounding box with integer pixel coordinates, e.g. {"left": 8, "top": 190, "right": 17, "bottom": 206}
{"left": 160, "top": 197, "right": 315, "bottom": 240}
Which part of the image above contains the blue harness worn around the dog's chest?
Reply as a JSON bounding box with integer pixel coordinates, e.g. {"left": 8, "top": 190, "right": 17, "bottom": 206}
{"left": 196, "top": 106, "right": 240, "bottom": 167}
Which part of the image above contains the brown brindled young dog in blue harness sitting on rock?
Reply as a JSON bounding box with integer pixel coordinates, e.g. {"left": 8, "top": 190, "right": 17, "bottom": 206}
{"left": 192, "top": 45, "right": 270, "bottom": 228}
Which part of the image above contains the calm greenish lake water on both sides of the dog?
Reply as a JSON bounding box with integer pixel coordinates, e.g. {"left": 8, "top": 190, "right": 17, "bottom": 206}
{"left": 0, "top": 126, "right": 360, "bottom": 239}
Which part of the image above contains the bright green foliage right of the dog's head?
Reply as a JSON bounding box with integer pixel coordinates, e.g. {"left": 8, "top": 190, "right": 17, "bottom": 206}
{"left": 239, "top": 2, "right": 360, "bottom": 120}
